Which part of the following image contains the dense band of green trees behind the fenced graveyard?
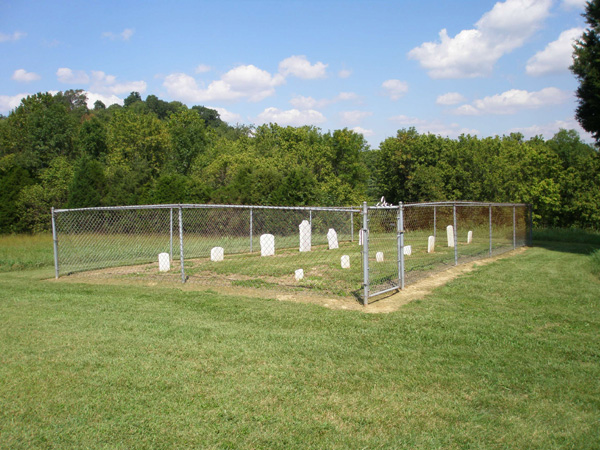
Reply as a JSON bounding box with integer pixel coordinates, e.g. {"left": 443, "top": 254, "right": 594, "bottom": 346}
{"left": 0, "top": 90, "right": 600, "bottom": 233}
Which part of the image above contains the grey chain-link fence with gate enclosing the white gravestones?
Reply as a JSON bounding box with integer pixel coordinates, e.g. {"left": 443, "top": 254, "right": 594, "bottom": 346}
{"left": 52, "top": 202, "right": 531, "bottom": 304}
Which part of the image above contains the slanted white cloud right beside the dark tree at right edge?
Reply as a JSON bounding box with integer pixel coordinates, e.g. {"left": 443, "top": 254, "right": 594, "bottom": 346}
{"left": 525, "top": 28, "right": 584, "bottom": 77}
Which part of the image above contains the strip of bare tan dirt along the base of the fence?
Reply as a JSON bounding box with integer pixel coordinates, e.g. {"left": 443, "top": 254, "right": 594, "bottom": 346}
{"left": 52, "top": 247, "right": 527, "bottom": 313}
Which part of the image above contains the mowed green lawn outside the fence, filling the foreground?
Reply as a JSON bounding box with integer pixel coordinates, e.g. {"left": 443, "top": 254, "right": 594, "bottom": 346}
{"left": 0, "top": 230, "right": 600, "bottom": 450}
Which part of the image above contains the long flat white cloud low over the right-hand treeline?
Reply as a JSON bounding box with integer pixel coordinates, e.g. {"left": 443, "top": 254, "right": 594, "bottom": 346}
{"left": 452, "top": 87, "right": 569, "bottom": 116}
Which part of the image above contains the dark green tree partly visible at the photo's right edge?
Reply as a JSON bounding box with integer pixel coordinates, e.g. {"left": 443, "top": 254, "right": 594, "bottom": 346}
{"left": 571, "top": 0, "right": 600, "bottom": 143}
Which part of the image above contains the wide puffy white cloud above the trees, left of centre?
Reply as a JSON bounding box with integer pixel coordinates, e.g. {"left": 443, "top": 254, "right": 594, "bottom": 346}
{"left": 163, "top": 65, "right": 285, "bottom": 102}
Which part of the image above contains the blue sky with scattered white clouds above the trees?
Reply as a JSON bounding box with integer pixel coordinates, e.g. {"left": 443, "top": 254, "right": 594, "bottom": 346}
{"left": 0, "top": 0, "right": 592, "bottom": 148}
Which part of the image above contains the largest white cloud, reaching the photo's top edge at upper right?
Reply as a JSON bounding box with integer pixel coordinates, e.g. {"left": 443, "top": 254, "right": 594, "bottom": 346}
{"left": 408, "top": 0, "right": 552, "bottom": 78}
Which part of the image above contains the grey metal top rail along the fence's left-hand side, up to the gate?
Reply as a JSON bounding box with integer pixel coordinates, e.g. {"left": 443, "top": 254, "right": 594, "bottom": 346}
{"left": 54, "top": 203, "right": 361, "bottom": 214}
